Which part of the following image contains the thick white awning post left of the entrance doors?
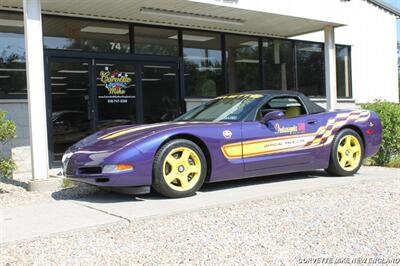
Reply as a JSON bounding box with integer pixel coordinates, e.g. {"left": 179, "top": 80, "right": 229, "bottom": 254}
{"left": 23, "top": 0, "right": 49, "bottom": 180}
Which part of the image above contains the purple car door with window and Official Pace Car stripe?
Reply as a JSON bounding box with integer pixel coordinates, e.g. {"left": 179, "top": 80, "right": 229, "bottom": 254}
{"left": 242, "top": 96, "right": 322, "bottom": 172}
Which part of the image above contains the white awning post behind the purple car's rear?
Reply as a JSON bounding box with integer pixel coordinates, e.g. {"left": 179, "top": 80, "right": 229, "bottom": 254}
{"left": 324, "top": 26, "right": 337, "bottom": 111}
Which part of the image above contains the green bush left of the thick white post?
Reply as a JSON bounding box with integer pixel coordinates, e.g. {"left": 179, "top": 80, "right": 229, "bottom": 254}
{"left": 0, "top": 111, "right": 16, "bottom": 177}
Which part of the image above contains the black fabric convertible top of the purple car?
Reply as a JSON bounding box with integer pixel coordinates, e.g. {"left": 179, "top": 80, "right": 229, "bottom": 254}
{"left": 236, "top": 90, "right": 326, "bottom": 114}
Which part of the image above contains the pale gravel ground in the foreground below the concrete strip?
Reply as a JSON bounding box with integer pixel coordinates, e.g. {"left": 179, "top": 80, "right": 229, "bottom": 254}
{"left": 0, "top": 178, "right": 400, "bottom": 265}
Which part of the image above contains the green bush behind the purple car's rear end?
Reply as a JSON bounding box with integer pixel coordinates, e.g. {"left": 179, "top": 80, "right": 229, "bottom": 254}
{"left": 362, "top": 101, "right": 400, "bottom": 166}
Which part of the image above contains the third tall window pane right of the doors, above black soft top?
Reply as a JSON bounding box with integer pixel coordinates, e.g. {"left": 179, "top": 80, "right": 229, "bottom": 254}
{"left": 263, "top": 39, "right": 294, "bottom": 90}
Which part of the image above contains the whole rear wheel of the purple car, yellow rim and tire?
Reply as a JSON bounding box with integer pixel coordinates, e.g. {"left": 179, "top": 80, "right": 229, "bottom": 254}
{"left": 326, "top": 128, "right": 364, "bottom": 176}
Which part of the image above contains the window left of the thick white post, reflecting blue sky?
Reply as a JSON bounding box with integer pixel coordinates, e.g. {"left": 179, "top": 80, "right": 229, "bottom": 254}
{"left": 0, "top": 12, "right": 27, "bottom": 98}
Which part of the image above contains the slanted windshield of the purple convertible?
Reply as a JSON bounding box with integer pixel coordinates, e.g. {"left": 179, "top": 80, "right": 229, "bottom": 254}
{"left": 175, "top": 94, "right": 263, "bottom": 122}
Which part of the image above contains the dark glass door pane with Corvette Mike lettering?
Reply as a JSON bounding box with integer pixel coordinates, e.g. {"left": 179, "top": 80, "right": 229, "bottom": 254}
{"left": 94, "top": 60, "right": 138, "bottom": 130}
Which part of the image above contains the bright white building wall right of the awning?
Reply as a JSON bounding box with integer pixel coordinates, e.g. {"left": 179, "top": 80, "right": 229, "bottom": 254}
{"left": 294, "top": 0, "right": 399, "bottom": 103}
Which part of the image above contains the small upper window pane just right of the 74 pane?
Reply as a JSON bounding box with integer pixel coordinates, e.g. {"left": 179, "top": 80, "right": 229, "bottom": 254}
{"left": 134, "top": 26, "right": 179, "bottom": 56}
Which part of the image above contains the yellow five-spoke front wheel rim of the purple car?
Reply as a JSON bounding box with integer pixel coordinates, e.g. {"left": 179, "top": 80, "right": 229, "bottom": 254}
{"left": 163, "top": 147, "right": 201, "bottom": 191}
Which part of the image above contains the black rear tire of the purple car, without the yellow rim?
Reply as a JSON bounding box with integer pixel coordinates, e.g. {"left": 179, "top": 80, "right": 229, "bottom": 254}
{"left": 325, "top": 128, "right": 364, "bottom": 176}
